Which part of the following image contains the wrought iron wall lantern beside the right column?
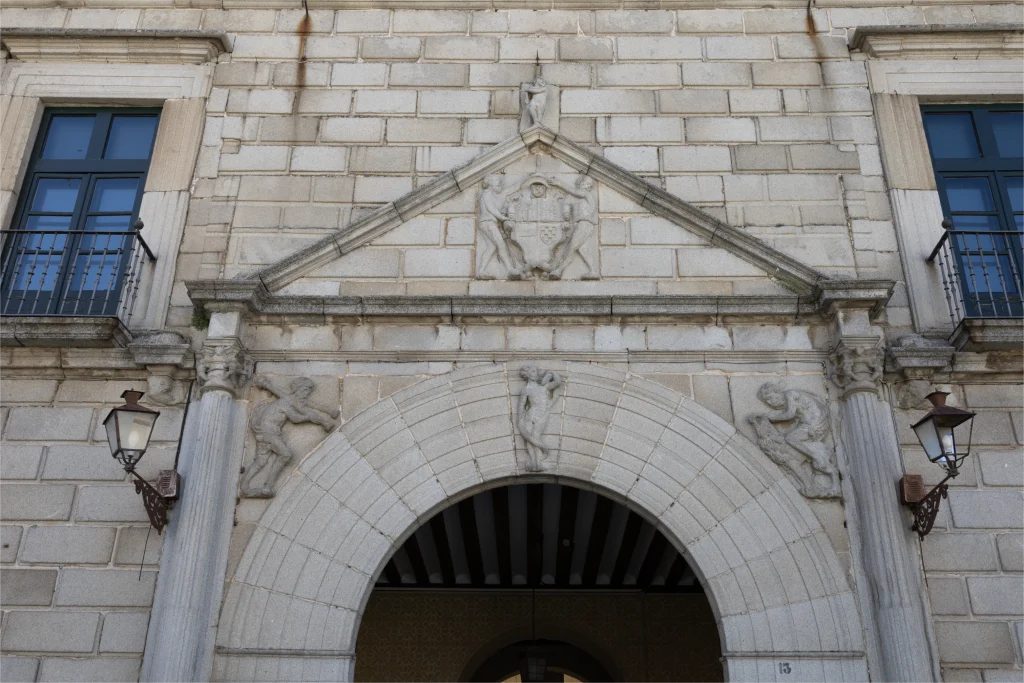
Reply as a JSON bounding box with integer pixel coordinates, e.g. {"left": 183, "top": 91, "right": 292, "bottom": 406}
{"left": 899, "top": 391, "right": 975, "bottom": 539}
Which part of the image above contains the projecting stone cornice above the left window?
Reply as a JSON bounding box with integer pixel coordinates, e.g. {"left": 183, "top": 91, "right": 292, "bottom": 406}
{"left": 0, "top": 29, "right": 231, "bottom": 65}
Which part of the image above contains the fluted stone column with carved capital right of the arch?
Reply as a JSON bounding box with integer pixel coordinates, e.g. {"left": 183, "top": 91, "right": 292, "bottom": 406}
{"left": 833, "top": 340, "right": 939, "bottom": 683}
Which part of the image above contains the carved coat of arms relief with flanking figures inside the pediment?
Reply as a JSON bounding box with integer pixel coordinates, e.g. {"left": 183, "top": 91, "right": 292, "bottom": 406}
{"left": 476, "top": 174, "right": 600, "bottom": 280}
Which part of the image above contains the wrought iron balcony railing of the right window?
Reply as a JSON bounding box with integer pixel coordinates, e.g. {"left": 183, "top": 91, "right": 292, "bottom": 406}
{"left": 928, "top": 219, "right": 1024, "bottom": 327}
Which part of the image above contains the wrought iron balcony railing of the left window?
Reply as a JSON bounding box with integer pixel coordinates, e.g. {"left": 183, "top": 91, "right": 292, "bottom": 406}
{"left": 0, "top": 227, "right": 156, "bottom": 327}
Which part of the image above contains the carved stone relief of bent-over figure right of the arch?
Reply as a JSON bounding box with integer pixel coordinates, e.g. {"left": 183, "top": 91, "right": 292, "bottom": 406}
{"left": 748, "top": 382, "right": 842, "bottom": 498}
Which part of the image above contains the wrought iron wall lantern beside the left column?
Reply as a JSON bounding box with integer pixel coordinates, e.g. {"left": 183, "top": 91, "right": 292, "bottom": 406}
{"left": 103, "top": 390, "right": 180, "bottom": 533}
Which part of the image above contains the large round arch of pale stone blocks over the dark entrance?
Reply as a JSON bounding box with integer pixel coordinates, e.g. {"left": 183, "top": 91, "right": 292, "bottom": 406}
{"left": 213, "top": 362, "right": 867, "bottom": 683}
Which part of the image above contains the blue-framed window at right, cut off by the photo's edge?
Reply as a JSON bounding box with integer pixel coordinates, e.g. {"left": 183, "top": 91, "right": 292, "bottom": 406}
{"left": 922, "top": 104, "right": 1024, "bottom": 317}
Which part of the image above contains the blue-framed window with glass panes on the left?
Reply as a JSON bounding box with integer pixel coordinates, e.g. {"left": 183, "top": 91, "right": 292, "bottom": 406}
{"left": 0, "top": 108, "right": 160, "bottom": 315}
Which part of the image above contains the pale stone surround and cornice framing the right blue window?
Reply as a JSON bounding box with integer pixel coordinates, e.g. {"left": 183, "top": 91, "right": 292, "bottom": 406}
{"left": 851, "top": 25, "right": 1024, "bottom": 338}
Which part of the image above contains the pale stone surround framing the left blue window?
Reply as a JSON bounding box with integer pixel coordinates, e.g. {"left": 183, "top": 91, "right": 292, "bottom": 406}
{"left": 0, "top": 45, "right": 220, "bottom": 336}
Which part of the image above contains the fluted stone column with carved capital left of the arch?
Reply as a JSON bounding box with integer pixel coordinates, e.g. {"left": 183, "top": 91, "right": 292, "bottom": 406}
{"left": 140, "top": 321, "right": 250, "bottom": 683}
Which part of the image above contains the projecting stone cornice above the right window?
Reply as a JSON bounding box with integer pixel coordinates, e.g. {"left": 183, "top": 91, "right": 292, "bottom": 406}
{"left": 850, "top": 24, "right": 1024, "bottom": 59}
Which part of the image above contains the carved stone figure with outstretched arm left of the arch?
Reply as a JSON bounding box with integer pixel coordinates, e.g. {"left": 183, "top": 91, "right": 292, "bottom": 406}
{"left": 242, "top": 377, "right": 338, "bottom": 498}
